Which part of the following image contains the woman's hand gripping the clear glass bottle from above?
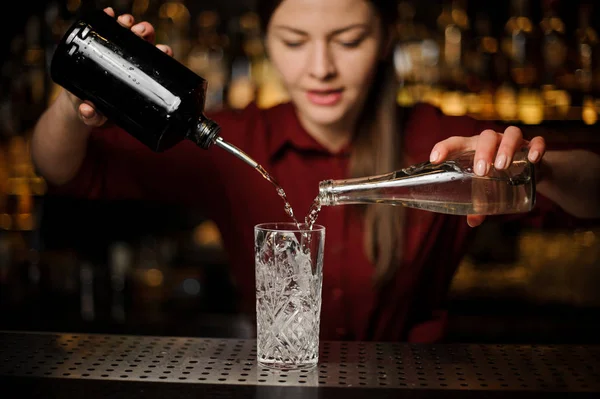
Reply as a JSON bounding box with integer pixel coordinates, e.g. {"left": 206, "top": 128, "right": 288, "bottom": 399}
{"left": 429, "top": 126, "right": 546, "bottom": 227}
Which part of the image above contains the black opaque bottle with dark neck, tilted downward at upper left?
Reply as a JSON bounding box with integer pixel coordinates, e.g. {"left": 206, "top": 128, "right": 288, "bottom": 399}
{"left": 50, "top": 10, "right": 220, "bottom": 152}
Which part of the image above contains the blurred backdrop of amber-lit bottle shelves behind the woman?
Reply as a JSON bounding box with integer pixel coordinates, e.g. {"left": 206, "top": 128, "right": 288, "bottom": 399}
{"left": 0, "top": 0, "right": 600, "bottom": 343}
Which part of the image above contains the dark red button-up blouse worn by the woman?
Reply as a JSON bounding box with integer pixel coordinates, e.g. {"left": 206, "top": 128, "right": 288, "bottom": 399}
{"left": 52, "top": 104, "right": 584, "bottom": 342}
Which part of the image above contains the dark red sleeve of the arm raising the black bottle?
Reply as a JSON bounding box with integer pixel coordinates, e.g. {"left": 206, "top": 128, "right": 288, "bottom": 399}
{"left": 49, "top": 104, "right": 256, "bottom": 211}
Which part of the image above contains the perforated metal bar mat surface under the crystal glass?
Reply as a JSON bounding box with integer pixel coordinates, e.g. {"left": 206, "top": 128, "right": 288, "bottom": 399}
{"left": 0, "top": 332, "right": 600, "bottom": 393}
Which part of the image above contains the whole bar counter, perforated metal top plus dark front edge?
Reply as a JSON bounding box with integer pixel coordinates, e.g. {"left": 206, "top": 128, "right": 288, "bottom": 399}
{"left": 0, "top": 331, "right": 600, "bottom": 399}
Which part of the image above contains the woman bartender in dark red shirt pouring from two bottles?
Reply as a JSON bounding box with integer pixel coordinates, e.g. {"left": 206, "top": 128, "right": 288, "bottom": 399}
{"left": 32, "top": 0, "right": 600, "bottom": 342}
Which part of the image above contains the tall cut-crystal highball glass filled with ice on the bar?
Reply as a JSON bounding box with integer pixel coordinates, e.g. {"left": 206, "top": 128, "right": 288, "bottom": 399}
{"left": 254, "top": 223, "right": 325, "bottom": 370}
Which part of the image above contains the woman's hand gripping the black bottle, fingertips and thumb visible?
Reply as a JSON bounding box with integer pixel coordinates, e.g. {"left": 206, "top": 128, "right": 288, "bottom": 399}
{"left": 64, "top": 7, "right": 173, "bottom": 127}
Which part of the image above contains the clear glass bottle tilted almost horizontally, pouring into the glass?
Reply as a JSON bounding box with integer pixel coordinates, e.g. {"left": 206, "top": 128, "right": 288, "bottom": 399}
{"left": 319, "top": 149, "right": 536, "bottom": 215}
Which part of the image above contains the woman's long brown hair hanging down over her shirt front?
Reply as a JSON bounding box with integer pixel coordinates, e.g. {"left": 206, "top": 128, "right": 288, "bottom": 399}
{"left": 257, "top": 0, "right": 404, "bottom": 286}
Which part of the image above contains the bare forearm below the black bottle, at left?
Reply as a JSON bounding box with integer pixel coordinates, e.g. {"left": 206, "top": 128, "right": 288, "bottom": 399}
{"left": 31, "top": 91, "right": 91, "bottom": 185}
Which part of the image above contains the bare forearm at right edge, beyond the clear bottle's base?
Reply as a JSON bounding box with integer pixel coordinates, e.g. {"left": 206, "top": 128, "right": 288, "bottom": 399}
{"left": 537, "top": 150, "right": 600, "bottom": 218}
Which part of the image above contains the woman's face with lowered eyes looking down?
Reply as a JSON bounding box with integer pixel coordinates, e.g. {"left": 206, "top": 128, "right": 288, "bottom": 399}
{"left": 267, "top": 0, "right": 384, "bottom": 134}
